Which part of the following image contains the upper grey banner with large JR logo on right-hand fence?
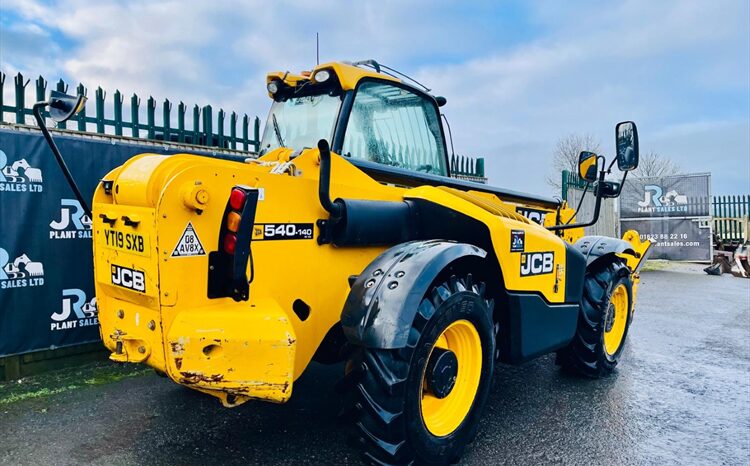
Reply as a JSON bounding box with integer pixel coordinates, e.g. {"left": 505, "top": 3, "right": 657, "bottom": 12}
{"left": 620, "top": 174, "right": 711, "bottom": 219}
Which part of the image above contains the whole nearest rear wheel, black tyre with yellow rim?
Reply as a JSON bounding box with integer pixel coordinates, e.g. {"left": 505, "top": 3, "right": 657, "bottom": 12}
{"left": 346, "top": 276, "right": 495, "bottom": 464}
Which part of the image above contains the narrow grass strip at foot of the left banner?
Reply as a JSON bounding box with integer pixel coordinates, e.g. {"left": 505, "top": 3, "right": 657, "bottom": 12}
{"left": 0, "top": 361, "right": 153, "bottom": 406}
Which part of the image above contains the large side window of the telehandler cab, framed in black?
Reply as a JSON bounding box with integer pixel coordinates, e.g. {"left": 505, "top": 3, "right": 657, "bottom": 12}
{"left": 342, "top": 81, "right": 447, "bottom": 175}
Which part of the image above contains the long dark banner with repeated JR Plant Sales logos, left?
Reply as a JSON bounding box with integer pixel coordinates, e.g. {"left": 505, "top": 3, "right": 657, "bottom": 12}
{"left": 0, "top": 129, "right": 238, "bottom": 356}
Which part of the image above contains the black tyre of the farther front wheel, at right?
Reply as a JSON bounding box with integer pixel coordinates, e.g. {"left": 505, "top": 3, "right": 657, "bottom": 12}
{"left": 557, "top": 258, "right": 633, "bottom": 378}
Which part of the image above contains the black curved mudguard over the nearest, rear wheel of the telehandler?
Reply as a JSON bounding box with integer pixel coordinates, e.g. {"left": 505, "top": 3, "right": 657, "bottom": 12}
{"left": 341, "top": 240, "right": 487, "bottom": 349}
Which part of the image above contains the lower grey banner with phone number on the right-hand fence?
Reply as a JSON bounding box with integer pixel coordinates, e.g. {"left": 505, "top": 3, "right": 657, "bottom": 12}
{"left": 621, "top": 218, "right": 711, "bottom": 261}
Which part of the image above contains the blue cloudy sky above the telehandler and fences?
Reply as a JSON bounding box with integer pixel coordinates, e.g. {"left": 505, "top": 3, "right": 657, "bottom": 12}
{"left": 0, "top": 0, "right": 750, "bottom": 194}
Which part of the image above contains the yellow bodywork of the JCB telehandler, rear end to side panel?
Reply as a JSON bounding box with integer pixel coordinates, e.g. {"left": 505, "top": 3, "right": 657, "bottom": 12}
{"left": 93, "top": 149, "right": 620, "bottom": 405}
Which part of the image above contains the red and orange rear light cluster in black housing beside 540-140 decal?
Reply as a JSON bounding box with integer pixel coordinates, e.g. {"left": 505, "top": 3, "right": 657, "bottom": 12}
{"left": 208, "top": 186, "right": 258, "bottom": 301}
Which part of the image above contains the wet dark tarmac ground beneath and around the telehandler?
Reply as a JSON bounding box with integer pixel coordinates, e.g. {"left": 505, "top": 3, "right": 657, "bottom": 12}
{"left": 0, "top": 269, "right": 750, "bottom": 465}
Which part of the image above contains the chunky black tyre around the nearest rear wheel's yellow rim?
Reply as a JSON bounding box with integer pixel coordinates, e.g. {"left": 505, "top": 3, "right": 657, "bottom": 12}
{"left": 342, "top": 275, "right": 495, "bottom": 464}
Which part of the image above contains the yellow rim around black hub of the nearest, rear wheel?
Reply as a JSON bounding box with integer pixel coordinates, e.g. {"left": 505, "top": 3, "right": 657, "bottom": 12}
{"left": 420, "top": 319, "right": 482, "bottom": 437}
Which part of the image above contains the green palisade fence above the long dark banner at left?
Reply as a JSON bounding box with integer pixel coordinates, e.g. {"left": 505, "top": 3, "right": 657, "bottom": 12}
{"left": 0, "top": 71, "right": 260, "bottom": 152}
